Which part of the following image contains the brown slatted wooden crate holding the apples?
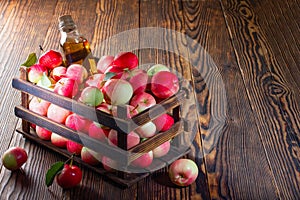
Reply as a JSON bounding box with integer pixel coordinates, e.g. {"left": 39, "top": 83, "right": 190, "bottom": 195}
{"left": 12, "top": 67, "right": 189, "bottom": 187}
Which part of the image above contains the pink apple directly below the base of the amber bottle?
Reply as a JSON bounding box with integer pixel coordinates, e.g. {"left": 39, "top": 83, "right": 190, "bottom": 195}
{"left": 66, "top": 64, "right": 88, "bottom": 84}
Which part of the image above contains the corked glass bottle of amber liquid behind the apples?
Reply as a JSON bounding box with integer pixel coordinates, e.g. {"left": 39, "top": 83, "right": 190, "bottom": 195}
{"left": 58, "top": 15, "right": 94, "bottom": 73}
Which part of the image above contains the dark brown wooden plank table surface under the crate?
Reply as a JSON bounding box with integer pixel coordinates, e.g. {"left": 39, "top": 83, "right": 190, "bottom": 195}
{"left": 0, "top": 0, "right": 300, "bottom": 200}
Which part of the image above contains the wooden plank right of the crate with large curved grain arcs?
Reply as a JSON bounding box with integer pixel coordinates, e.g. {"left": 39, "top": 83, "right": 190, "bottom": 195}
{"left": 183, "top": 0, "right": 278, "bottom": 199}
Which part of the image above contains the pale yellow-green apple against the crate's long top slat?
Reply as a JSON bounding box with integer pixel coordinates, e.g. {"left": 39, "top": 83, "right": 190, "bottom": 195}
{"left": 79, "top": 86, "right": 103, "bottom": 107}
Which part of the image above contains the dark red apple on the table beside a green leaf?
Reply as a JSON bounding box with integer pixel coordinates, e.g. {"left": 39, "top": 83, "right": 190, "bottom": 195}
{"left": 56, "top": 164, "right": 82, "bottom": 189}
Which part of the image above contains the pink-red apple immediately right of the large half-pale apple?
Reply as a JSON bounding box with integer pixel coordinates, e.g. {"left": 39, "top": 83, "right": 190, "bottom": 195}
{"left": 128, "top": 69, "right": 148, "bottom": 94}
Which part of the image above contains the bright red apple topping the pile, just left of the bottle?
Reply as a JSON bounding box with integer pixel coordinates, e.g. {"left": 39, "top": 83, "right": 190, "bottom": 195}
{"left": 39, "top": 49, "right": 63, "bottom": 70}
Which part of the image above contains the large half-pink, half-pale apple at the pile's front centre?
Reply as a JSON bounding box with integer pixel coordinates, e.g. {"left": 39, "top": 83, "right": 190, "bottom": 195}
{"left": 102, "top": 79, "right": 133, "bottom": 105}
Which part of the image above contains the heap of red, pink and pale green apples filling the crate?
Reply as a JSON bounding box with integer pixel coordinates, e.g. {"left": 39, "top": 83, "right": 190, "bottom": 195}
{"left": 27, "top": 50, "right": 180, "bottom": 170}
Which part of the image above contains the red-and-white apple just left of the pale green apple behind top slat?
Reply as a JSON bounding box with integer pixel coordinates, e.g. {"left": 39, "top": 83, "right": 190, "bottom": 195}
{"left": 53, "top": 78, "right": 78, "bottom": 98}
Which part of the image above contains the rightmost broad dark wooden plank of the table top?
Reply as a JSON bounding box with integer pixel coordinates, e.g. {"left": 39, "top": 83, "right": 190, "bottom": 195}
{"left": 222, "top": 1, "right": 300, "bottom": 199}
